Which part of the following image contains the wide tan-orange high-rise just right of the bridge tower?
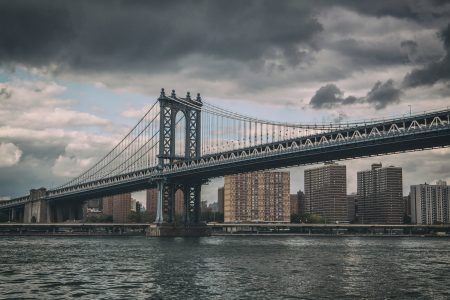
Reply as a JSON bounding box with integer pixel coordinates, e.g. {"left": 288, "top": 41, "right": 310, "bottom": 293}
{"left": 224, "top": 172, "right": 290, "bottom": 222}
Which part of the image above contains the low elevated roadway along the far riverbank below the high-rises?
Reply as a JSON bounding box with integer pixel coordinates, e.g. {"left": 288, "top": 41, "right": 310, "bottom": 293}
{"left": 0, "top": 222, "right": 450, "bottom": 237}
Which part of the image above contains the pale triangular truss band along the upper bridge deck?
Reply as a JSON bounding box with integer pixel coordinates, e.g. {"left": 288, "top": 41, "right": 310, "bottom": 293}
{"left": 0, "top": 106, "right": 450, "bottom": 203}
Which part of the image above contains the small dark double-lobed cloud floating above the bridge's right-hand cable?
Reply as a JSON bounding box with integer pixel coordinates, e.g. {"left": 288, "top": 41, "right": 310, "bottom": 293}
{"left": 309, "top": 79, "right": 402, "bottom": 109}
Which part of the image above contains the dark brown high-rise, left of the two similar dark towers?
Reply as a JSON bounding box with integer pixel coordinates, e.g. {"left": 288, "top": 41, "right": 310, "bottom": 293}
{"left": 304, "top": 163, "right": 348, "bottom": 223}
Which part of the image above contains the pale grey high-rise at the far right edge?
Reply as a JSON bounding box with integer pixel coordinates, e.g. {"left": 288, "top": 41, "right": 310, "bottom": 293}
{"left": 410, "top": 181, "right": 450, "bottom": 225}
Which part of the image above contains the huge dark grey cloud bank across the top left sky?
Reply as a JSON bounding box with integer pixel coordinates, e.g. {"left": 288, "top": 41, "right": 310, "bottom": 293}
{"left": 0, "top": 0, "right": 322, "bottom": 72}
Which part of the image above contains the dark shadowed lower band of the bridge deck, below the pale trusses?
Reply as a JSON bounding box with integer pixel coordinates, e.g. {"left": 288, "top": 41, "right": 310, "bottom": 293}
{"left": 4, "top": 128, "right": 450, "bottom": 202}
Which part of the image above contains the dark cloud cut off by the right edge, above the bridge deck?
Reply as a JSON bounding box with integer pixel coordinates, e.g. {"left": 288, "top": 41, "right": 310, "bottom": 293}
{"left": 403, "top": 24, "right": 450, "bottom": 87}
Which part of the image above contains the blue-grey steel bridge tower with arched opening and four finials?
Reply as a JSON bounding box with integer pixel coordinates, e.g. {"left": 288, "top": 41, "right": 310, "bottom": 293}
{"left": 155, "top": 89, "right": 203, "bottom": 224}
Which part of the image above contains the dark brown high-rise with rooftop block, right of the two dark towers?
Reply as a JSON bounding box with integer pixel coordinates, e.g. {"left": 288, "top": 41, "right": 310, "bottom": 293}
{"left": 357, "top": 163, "right": 404, "bottom": 224}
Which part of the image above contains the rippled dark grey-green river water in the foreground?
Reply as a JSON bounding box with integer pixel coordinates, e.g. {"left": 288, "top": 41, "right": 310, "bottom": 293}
{"left": 0, "top": 236, "right": 450, "bottom": 299}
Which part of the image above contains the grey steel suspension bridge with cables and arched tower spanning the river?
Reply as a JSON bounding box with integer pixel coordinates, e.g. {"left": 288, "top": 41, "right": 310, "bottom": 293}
{"left": 0, "top": 89, "right": 450, "bottom": 229}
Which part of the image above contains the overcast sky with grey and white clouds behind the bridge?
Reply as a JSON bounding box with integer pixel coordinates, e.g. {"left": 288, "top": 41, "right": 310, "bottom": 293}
{"left": 0, "top": 0, "right": 450, "bottom": 202}
